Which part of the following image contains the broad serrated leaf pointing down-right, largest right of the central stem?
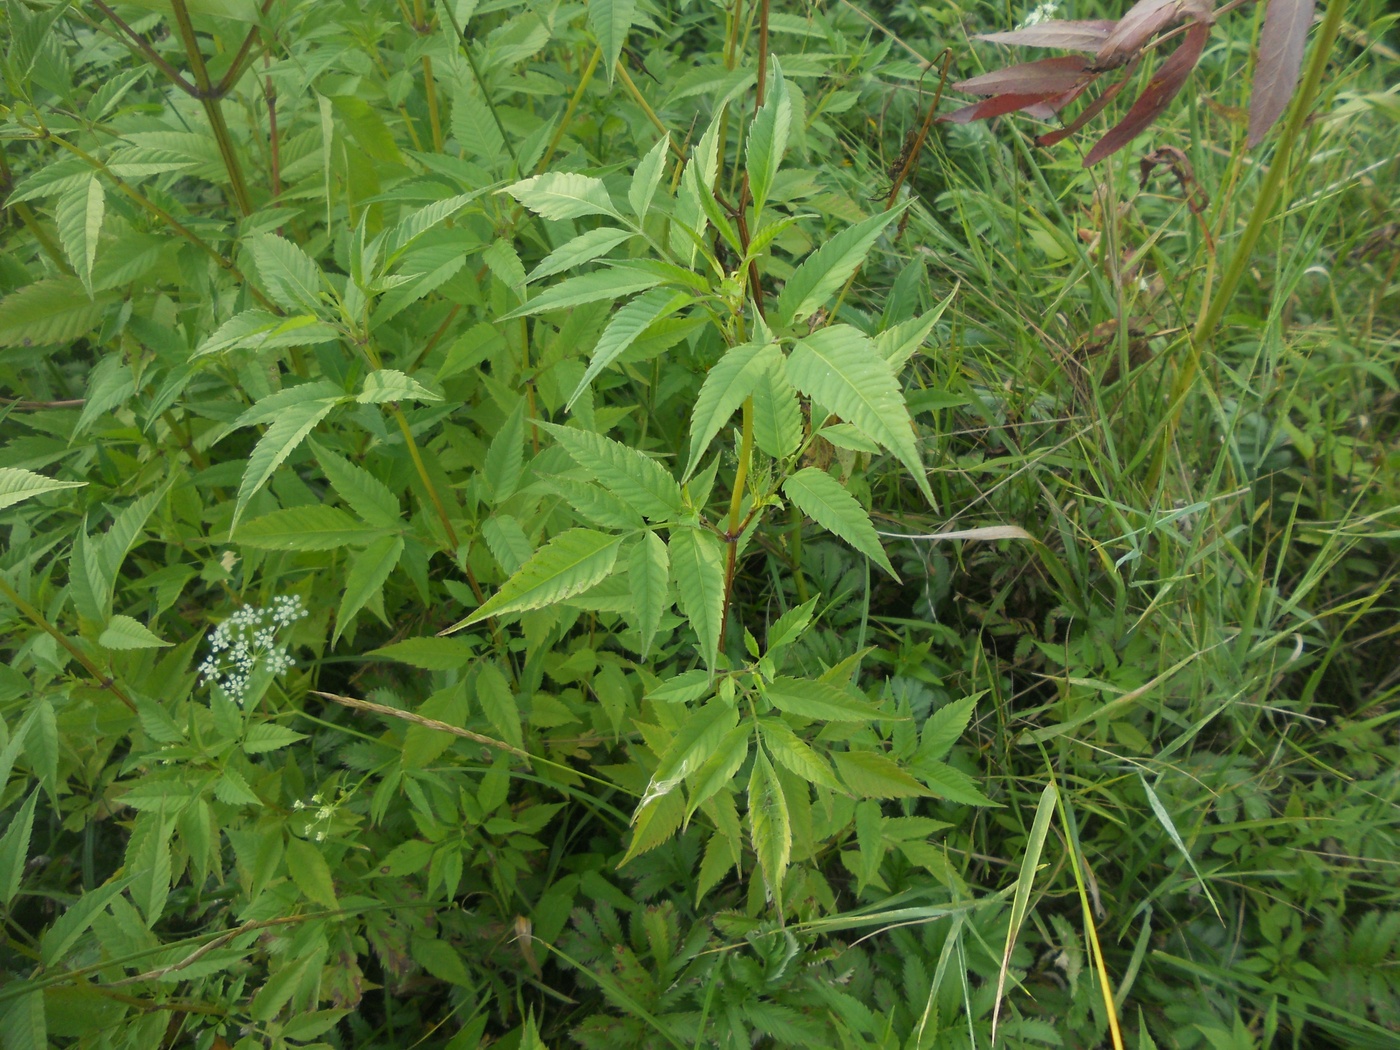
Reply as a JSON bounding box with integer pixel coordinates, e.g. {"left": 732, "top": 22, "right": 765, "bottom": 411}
{"left": 787, "top": 325, "right": 934, "bottom": 503}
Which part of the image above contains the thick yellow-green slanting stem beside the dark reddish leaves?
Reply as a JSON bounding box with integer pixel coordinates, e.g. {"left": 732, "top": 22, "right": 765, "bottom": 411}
{"left": 1148, "top": 0, "right": 1347, "bottom": 487}
